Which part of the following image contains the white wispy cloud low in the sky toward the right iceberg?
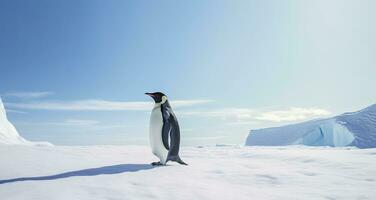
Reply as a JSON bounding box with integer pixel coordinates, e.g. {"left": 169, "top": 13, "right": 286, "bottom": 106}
{"left": 178, "top": 107, "right": 331, "bottom": 124}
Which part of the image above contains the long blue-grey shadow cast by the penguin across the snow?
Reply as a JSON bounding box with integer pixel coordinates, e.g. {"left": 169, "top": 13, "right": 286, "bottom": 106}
{"left": 0, "top": 164, "right": 156, "bottom": 184}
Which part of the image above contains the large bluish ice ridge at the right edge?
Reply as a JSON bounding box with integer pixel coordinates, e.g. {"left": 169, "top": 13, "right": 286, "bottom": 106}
{"left": 246, "top": 104, "right": 376, "bottom": 148}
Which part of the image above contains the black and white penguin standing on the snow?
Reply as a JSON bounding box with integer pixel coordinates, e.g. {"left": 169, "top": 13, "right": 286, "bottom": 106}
{"left": 145, "top": 92, "right": 187, "bottom": 166}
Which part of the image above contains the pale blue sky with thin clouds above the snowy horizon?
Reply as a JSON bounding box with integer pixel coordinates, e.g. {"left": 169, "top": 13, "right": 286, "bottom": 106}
{"left": 0, "top": 0, "right": 376, "bottom": 145}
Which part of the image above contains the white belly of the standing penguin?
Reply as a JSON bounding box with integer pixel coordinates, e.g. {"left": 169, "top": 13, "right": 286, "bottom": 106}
{"left": 149, "top": 106, "right": 168, "bottom": 164}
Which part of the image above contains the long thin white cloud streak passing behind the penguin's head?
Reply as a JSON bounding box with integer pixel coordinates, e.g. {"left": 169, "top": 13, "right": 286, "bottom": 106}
{"left": 7, "top": 99, "right": 211, "bottom": 111}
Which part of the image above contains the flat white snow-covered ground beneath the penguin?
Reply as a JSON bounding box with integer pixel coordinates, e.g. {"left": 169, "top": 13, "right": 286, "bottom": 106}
{"left": 0, "top": 145, "right": 376, "bottom": 200}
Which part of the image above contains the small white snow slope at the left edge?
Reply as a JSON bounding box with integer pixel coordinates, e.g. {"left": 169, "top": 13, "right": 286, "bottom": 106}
{"left": 0, "top": 98, "right": 31, "bottom": 144}
